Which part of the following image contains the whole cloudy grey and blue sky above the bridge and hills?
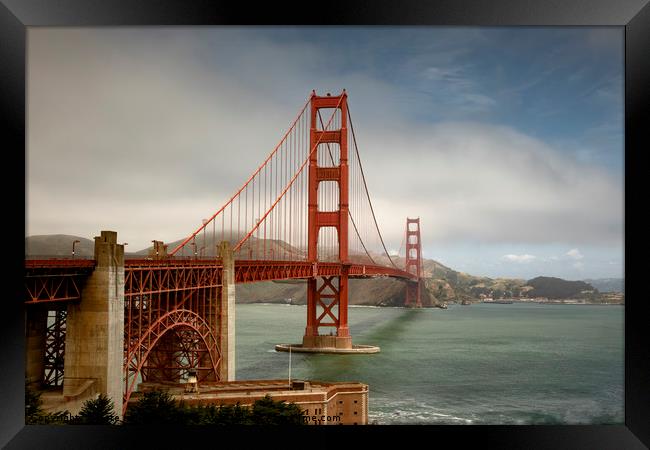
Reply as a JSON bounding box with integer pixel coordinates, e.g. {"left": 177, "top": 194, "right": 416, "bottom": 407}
{"left": 25, "top": 26, "right": 624, "bottom": 280}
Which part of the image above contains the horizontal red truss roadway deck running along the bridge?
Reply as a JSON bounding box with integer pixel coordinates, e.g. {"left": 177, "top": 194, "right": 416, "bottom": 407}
{"left": 24, "top": 258, "right": 417, "bottom": 304}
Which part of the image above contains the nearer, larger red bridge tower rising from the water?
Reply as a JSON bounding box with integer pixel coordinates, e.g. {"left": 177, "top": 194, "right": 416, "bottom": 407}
{"left": 303, "top": 90, "right": 352, "bottom": 349}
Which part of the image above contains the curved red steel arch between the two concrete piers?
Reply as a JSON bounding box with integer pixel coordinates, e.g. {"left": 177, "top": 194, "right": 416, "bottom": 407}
{"left": 123, "top": 309, "right": 221, "bottom": 413}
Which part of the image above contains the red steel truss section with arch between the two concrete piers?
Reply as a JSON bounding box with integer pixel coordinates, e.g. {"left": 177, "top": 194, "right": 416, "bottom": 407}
{"left": 124, "top": 260, "right": 223, "bottom": 408}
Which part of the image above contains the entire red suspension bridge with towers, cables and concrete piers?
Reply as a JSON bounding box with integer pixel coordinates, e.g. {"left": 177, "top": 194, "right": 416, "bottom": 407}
{"left": 25, "top": 90, "right": 423, "bottom": 410}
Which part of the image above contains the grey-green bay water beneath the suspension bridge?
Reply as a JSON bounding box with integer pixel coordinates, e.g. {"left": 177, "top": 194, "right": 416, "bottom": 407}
{"left": 236, "top": 303, "right": 624, "bottom": 425}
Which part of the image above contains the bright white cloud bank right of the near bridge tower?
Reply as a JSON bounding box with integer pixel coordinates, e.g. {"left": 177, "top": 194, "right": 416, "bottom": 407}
{"left": 357, "top": 122, "right": 623, "bottom": 250}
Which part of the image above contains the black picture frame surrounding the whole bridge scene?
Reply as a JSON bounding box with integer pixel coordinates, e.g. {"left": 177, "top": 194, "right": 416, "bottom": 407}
{"left": 0, "top": 0, "right": 650, "bottom": 449}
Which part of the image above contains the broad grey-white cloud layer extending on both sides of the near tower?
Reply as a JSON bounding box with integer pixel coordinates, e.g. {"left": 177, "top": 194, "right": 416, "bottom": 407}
{"left": 26, "top": 29, "right": 623, "bottom": 256}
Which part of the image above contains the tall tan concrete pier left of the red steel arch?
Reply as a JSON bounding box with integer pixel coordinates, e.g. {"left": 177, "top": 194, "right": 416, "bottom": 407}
{"left": 63, "top": 231, "right": 124, "bottom": 418}
